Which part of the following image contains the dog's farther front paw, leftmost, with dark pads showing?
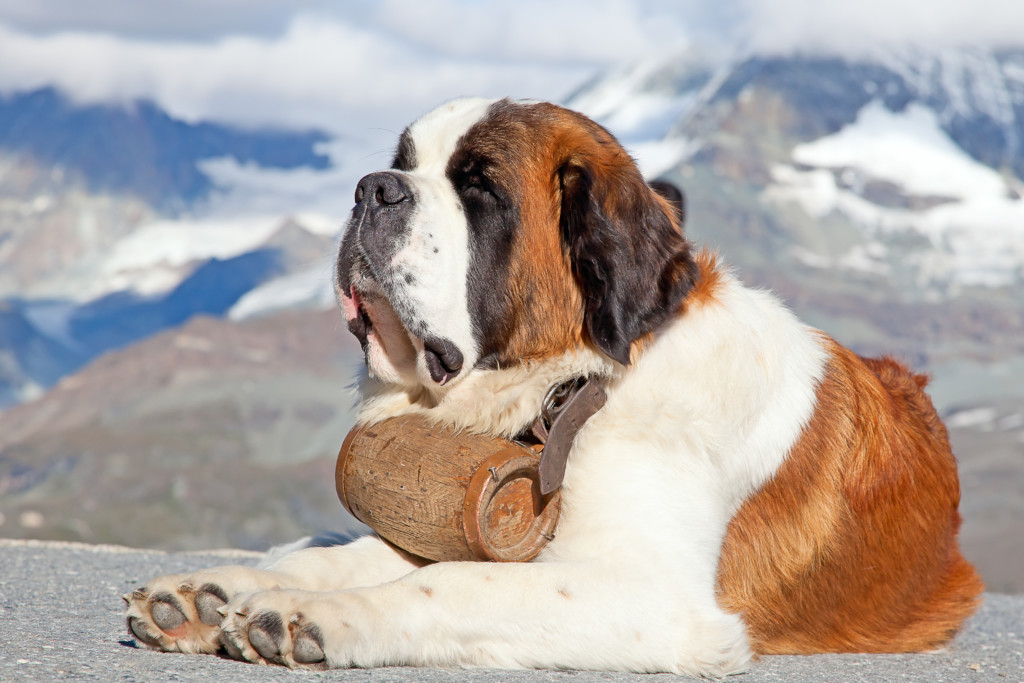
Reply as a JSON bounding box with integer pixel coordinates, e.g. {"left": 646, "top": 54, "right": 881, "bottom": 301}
{"left": 123, "top": 566, "right": 275, "bottom": 654}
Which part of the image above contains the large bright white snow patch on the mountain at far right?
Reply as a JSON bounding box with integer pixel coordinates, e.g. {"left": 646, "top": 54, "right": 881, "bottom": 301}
{"left": 762, "top": 102, "right": 1024, "bottom": 294}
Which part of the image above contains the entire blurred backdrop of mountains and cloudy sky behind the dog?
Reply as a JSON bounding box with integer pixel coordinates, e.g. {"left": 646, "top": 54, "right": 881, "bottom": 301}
{"left": 0, "top": 0, "right": 1024, "bottom": 592}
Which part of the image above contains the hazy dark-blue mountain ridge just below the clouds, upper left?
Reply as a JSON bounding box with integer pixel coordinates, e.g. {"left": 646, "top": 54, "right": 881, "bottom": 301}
{"left": 0, "top": 88, "right": 331, "bottom": 211}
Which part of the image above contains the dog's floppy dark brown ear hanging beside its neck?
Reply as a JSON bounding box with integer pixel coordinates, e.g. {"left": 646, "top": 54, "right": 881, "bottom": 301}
{"left": 559, "top": 161, "right": 696, "bottom": 365}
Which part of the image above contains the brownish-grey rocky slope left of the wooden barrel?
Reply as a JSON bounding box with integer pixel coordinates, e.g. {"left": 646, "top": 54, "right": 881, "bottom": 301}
{"left": 0, "top": 311, "right": 361, "bottom": 549}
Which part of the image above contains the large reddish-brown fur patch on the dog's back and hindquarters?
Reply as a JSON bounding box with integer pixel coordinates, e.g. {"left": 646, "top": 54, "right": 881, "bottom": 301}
{"left": 718, "top": 339, "right": 983, "bottom": 654}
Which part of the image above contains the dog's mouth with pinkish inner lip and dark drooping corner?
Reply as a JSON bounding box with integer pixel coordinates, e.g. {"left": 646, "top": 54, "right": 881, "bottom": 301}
{"left": 341, "top": 275, "right": 465, "bottom": 386}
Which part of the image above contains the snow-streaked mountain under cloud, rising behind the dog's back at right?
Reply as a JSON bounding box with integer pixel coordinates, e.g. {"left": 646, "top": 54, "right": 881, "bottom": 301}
{"left": 569, "top": 49, "right": 1024, "bottom": 389}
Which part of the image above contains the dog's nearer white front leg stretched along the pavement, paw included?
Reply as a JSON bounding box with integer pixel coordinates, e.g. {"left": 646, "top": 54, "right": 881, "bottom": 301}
{"left": 223, "top": 562, "right": 750, "bottom": 675}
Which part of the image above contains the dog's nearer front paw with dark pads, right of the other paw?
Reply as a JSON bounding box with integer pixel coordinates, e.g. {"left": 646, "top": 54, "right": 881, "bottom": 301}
{"left": 220, "top": 591, "right": 331, "bottom": 671}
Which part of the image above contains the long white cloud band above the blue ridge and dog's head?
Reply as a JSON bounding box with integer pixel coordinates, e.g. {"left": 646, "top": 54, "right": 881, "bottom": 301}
{"left": 0, "top": 17, "right": 589, "bottom": 132}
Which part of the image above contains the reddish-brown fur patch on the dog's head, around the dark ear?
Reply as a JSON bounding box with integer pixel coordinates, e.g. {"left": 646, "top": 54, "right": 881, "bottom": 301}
{"left": 450, "top": 100, "right": 692, "bottom": 366}
